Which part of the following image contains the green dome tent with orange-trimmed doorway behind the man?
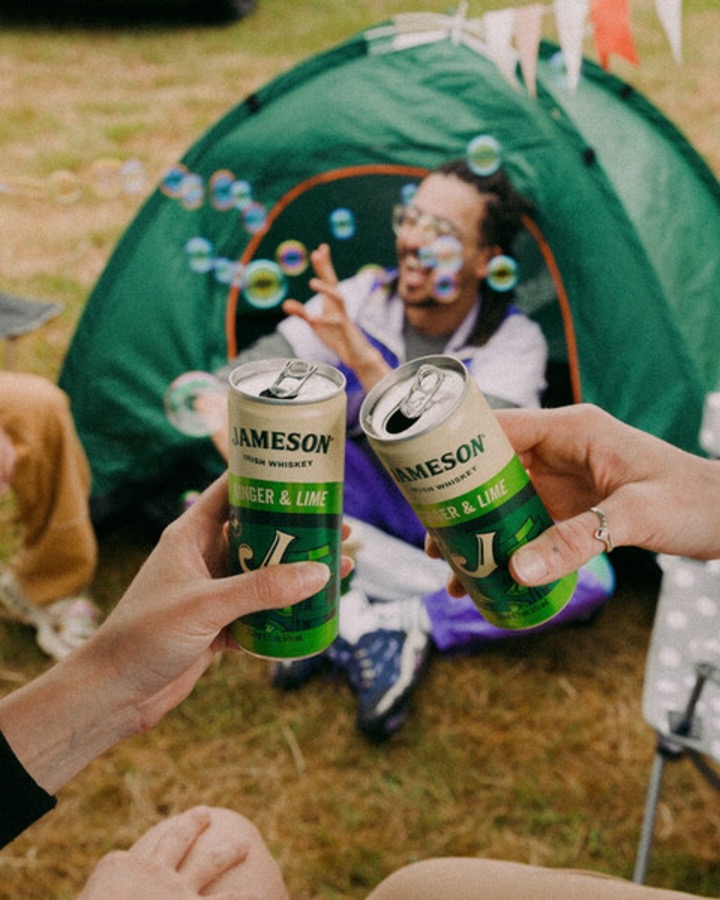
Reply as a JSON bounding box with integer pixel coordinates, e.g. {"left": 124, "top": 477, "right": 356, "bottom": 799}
{"left": 61, "top": 16, "right": 720, "bottom": 520}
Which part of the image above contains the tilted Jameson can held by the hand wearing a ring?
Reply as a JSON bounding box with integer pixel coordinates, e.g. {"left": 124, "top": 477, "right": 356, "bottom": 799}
{"left": 360, "top": 356, "right": 577, "bottom": 629}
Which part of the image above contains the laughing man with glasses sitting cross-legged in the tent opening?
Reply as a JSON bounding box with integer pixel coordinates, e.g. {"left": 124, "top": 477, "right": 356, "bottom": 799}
{"left": 198, "top": 159, "right": 611, "bottom": 740}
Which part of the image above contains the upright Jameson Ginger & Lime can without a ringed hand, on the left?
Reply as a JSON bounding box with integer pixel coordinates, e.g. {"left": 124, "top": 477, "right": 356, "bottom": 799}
{"left": 228, "top": 359, "right": 346, "bottom": 659}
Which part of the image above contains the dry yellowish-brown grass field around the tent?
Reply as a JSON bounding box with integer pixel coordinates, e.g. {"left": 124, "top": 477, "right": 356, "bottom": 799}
{"left": 0, "top": 0, "right": 720, "bottom": 900}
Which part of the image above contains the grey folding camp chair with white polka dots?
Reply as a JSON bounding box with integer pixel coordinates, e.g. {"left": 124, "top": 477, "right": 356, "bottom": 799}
{"left": 633, "top": 556, "right": 720, "bottom": 884}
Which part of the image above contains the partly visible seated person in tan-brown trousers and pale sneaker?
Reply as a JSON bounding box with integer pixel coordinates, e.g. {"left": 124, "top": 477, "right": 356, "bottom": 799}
{"left": 0, "top": 371, "right": 99, "bottom": 660}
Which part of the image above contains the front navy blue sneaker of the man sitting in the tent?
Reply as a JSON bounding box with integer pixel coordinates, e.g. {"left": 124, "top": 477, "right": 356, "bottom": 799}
{"left": 326, "top": 627, "right": 430, "bottom": 742}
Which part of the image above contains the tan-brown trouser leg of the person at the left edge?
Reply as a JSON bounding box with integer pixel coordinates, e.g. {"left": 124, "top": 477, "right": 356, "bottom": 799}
{"left": 0, "top": 372, "right": 97, "bottom": 605}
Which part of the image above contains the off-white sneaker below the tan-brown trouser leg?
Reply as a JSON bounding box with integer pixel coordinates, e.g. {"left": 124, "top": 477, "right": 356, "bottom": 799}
{"left": 0, "top": 572, "right": 100, "bottom": 659}
